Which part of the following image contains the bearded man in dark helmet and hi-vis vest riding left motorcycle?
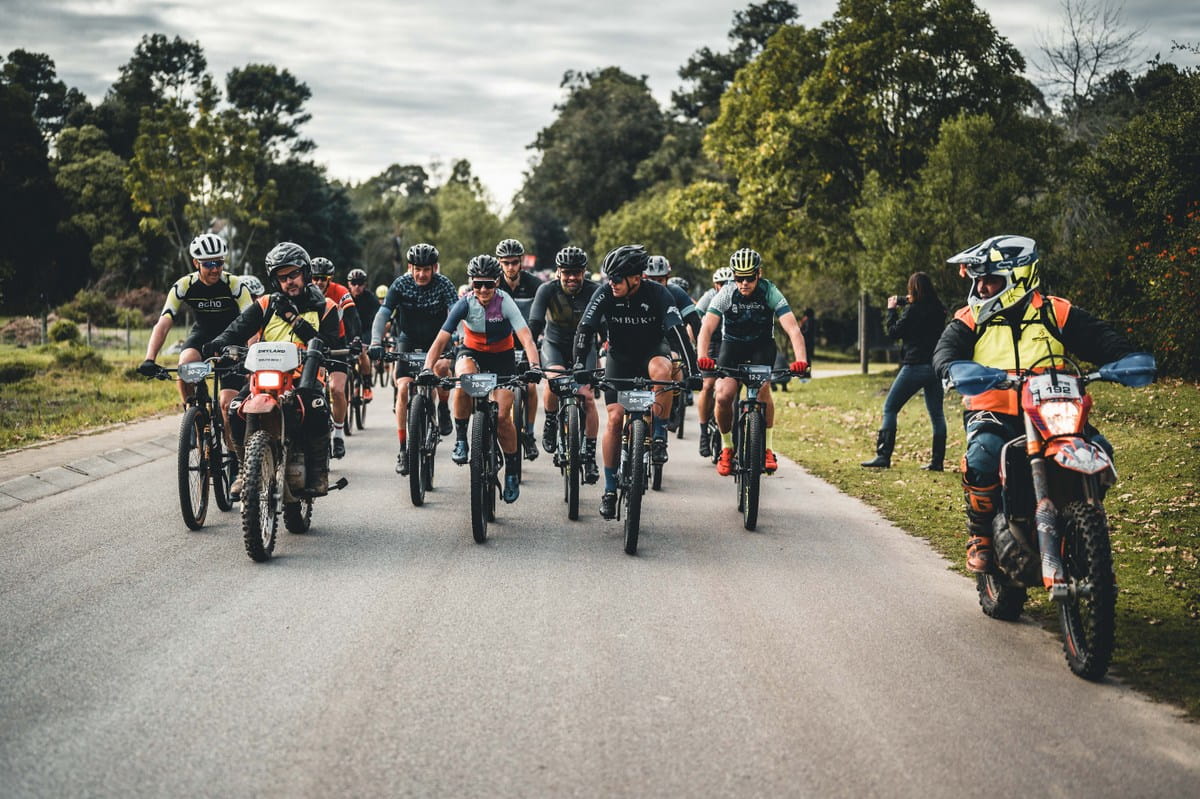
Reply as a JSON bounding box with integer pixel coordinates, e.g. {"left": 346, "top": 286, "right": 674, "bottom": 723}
{"left": 203, "top": 241, "right": 342, "bottom": 497}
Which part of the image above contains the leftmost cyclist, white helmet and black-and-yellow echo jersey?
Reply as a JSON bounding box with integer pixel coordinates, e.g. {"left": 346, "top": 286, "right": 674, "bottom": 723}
{"left": 138, "top": 233, "right": 251, "bottom": 441}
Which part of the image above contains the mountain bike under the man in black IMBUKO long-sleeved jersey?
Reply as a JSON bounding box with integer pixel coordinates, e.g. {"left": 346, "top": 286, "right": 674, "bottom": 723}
{"left": 596, "top": 378, "right": 686, "bottom": 555}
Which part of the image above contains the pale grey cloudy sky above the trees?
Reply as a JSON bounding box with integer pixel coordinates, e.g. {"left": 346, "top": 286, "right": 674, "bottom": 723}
{"left": 0, "top": 0, "right": 1200, "bottom": 206}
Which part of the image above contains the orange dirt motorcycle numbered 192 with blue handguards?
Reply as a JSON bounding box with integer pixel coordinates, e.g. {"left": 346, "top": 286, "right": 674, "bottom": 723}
{"left": 948, "top": 353, "right": 1156, "bottom": 680}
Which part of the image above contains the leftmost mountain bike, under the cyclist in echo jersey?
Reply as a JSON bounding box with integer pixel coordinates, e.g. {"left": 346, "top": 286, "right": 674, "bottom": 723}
{"left": 144, "top": 358, "right": 241, "bottom": 530}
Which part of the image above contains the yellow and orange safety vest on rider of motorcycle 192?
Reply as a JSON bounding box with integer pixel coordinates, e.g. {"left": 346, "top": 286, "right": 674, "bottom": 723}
{"left": 954, "top": 292, "right": 1070, "bottom": 416}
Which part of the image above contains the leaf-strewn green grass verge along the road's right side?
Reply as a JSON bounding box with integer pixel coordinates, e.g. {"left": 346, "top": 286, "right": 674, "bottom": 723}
{"left": 775, "top": 373, "right": 1200, "bottom": 717}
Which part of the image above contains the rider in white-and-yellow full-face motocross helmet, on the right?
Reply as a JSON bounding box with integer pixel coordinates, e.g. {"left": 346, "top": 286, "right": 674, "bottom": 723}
{"left": 934, "top": 234, "right": 1134, "bottom": 573}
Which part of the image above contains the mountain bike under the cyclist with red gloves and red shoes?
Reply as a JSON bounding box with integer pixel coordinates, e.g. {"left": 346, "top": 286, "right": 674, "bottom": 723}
{"left": 715, "top": 364, "right": 791, "bottom": 530}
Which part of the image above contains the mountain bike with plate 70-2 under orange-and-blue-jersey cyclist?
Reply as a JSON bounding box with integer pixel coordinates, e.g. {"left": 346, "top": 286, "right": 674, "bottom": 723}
{"left": 439, "top": 372, "right": 526, "bottom": 543}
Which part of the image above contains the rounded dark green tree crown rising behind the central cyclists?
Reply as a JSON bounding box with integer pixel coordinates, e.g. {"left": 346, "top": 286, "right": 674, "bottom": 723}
{"left": 517, "top": 67, "right": 664, "bottom": 252}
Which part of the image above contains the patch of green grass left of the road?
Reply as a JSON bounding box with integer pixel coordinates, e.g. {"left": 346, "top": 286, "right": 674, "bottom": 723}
{"left": 0, "top": 336, "right": 179, "bottom": 451}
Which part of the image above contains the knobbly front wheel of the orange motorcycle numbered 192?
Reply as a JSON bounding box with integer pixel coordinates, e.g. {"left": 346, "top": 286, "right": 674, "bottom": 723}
{"left": 1058, "top": 501, "right": 1117, "bottom": 680}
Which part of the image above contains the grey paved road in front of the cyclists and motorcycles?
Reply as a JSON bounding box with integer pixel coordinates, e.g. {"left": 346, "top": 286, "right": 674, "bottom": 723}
{"left": 0, "top": 405, "right": 1200, "bottom": 797}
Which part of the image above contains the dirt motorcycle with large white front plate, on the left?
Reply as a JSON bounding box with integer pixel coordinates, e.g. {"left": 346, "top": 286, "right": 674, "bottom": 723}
{"left": 227, "top": 338, "right": 349, "bottom": 563}
